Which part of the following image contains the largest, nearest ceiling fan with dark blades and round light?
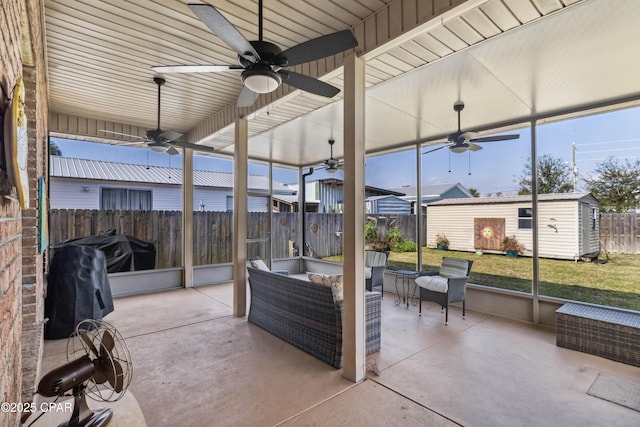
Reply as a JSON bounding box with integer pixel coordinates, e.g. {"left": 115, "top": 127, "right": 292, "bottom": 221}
{"left": 152, "top": 0, "right": 358, "bottom": 107}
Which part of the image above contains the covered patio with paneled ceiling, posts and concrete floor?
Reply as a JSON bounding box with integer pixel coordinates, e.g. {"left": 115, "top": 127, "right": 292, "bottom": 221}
{"left": 0, "top": 0, "right": 640, "bottom": 426}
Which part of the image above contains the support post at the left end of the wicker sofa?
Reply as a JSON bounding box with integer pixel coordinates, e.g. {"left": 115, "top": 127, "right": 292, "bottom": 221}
{"left": 233, "top": 118, "right": 249, "bottom": 317}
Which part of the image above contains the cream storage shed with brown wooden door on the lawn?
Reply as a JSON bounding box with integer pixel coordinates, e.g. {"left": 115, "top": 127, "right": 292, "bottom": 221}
{"left": 427, "top": 193, "right": 600, "bottom": 260}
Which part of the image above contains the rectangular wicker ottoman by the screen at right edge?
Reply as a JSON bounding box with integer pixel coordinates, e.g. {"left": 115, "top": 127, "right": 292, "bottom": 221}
{"left": 556, "top": 303, "right": 640, "bottom": 366}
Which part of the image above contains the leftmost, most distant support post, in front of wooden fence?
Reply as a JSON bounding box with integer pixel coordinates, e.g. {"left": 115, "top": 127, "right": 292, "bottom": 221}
{"left": 182, "top": 148, "right": 193, "bottom": 288}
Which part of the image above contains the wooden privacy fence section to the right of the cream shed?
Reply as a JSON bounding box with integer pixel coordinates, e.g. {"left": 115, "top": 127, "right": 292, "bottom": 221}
{"left": 600, "top": 213, "right": 640, "bottom": 254}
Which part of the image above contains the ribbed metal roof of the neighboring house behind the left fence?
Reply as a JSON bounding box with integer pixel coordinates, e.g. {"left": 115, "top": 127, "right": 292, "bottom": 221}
{"left": 49, "top": 156, "right": 295, "bottom": 194}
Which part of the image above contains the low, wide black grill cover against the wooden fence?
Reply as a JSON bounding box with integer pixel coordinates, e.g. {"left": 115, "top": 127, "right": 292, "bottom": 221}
{"left": 54, "top": 234, "right": 156, "bottom": 273}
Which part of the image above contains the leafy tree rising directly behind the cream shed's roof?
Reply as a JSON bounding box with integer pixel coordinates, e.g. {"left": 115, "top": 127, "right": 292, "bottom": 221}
{"left": 518, "top": 154, "right": 573, "bottom": 195}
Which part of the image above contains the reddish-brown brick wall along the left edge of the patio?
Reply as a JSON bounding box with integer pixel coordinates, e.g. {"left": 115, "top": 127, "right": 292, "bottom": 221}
{"left": 0, "top": 0, "right": 47, "bottom": 426}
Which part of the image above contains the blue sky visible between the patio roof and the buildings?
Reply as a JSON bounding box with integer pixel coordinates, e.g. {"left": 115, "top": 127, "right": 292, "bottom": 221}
{"left": 51, "top": 107, "right": 640, "bottom": 196}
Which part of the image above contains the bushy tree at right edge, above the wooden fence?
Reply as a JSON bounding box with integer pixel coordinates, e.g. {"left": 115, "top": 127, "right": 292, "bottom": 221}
{"left": 584, "top": 157, "right": 640, "bottom": 213}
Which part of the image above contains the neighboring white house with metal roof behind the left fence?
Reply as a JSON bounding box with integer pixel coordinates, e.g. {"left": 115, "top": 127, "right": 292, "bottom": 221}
{"left": 49, "top": 156, "right": 295, "bottom": 212}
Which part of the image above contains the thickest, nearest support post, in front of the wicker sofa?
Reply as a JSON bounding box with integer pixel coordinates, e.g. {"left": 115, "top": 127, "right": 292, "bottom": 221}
{"left": 342, "top": 54, "right": 366, "bottom": 382}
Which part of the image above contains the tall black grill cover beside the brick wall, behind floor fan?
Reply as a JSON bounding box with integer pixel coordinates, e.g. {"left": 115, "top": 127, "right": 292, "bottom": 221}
{"left": 44, "top": 245, "right": 113, "bottom": 339}
